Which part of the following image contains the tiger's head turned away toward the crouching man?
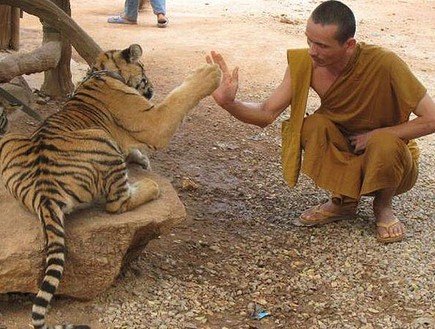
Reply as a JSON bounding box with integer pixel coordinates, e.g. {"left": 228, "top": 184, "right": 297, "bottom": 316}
{"left": 92, "top": 44, "right": 154, "bottom": 99}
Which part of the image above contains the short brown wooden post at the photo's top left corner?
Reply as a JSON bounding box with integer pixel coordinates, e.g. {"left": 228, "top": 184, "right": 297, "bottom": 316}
{"left": 0, "top": 5, "right": 20, "bottom": 50}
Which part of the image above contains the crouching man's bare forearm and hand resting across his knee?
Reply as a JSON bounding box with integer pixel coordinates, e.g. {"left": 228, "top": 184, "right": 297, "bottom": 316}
{"left": 350, "top": 94, "right": 435, "bottom": 153}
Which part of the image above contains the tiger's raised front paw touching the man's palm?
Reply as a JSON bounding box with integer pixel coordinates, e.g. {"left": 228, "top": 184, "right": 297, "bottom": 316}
{"left": 186, "top": 64, "right": 222, "bottom": 98}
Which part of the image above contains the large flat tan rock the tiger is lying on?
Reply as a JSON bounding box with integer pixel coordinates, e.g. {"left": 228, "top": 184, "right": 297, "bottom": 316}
{"left": 0, "top": 171, "right": 186, "bottom": 299}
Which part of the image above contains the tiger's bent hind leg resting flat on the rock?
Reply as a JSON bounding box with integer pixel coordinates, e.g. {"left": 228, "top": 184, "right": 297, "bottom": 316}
{"left": 106, "top": 169, "right": 160, "bottom": 213}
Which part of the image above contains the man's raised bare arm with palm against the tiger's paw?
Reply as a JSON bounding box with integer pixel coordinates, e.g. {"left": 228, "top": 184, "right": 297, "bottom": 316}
{"left": 206, "top": 51, "right": 292, "bottom": 127}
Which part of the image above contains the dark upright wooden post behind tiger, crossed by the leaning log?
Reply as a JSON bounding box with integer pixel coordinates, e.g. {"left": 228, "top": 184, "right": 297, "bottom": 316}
{"left": 41, "top": 0, "right": 74, "bottom": 97}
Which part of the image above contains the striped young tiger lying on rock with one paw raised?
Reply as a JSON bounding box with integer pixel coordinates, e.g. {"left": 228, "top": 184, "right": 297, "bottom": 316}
{"left": 0, "top": 44, "right": 221, "bottom": 329}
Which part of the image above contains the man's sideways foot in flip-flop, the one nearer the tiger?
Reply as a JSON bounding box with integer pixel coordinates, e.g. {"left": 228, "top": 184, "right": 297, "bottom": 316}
{"left": 298, "top": 205, "right": 356, "bottom": 226}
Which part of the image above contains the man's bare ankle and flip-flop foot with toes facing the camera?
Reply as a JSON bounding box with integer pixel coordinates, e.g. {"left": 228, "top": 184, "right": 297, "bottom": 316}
{"left": 373, "top": 188, "right": 406, "bottom": 242}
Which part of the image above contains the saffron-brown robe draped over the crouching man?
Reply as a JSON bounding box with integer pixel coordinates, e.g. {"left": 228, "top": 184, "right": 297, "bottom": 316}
{"left": 282, "top": 43, "right": 426, "bottom": 199}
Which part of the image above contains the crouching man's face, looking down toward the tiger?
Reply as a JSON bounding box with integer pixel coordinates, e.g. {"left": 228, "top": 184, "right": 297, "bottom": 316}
{"left": 305, "top": 18, "right": 349, "bottom": 66}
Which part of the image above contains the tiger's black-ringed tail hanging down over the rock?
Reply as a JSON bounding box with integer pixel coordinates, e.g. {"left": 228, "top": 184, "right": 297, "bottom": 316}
{"left": 32, "top": 200, "right": 90, "bottom": 329}
